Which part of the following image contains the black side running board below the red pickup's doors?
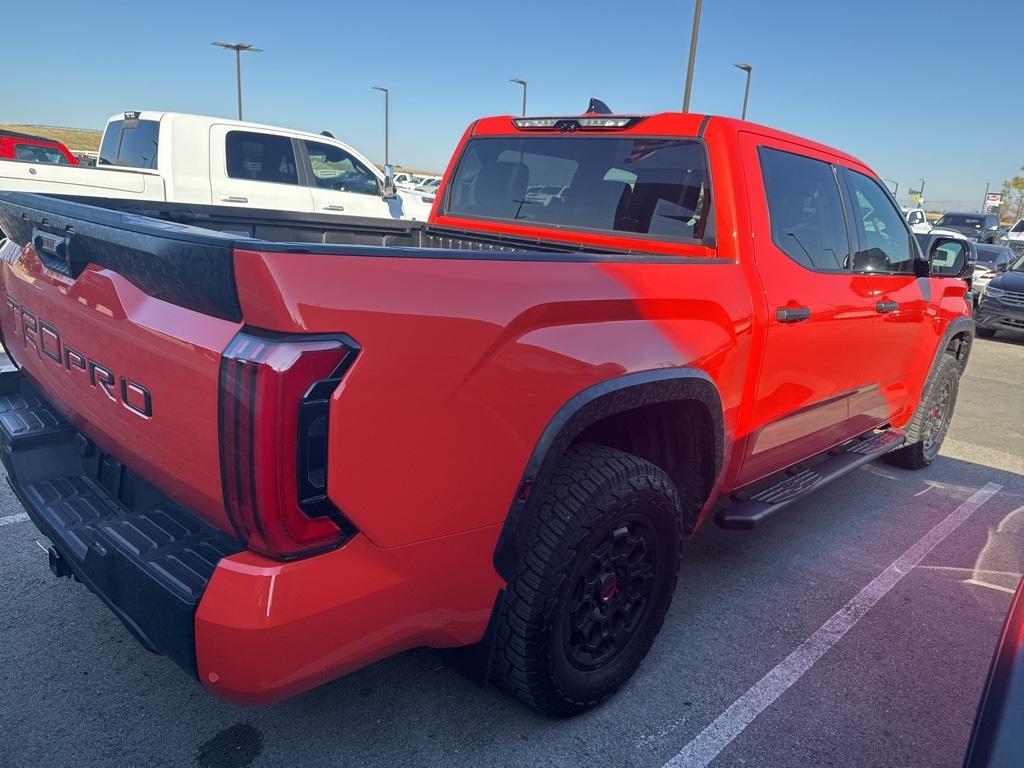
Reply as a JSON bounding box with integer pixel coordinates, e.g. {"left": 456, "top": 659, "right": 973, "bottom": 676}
{"left": 715, "top": 429, "right": 906, "bottom": 530}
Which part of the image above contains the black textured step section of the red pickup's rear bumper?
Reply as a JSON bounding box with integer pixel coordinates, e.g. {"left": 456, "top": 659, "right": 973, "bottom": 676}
{"left": 0, "top": 372, "right": 242, "bottom": 675}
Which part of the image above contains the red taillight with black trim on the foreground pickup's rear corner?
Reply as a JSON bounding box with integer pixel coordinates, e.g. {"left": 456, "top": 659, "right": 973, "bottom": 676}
{"left": 219, "top": 333, "right": 358, "bottom": 559}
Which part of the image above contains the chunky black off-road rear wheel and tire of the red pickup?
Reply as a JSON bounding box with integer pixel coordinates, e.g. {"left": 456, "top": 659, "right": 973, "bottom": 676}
{"left": 490, "top": 444, "right": 683, "bottom": 717}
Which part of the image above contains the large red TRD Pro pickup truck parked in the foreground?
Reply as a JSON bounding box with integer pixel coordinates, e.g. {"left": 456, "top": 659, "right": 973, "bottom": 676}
{"left": 0, "top": 114, "right": 974, "bottom": 716}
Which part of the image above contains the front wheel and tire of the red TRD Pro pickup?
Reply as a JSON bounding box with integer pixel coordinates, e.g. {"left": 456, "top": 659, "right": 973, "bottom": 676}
{"left": 886, "top": 354, "right": 961, "bottom": 469}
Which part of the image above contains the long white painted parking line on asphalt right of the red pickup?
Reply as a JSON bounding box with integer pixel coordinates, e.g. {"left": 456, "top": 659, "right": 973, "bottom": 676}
{"left": 665, "top": 482, "right": 1002, "bottom": 768}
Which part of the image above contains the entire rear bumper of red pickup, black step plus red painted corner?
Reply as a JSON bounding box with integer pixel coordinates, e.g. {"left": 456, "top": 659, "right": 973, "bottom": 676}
{"left": 0, "top": 373, "right": 503, "bottom": 706}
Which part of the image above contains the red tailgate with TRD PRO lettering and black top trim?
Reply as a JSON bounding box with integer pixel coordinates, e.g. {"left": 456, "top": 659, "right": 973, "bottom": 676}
{"left": 0, "top": 194, "right": 241, "bottom": 531}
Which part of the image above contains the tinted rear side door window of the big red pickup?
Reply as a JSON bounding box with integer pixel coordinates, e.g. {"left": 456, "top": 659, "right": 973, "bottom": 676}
{"left": 758, "top": 146, "right": 850, "bottom": 270}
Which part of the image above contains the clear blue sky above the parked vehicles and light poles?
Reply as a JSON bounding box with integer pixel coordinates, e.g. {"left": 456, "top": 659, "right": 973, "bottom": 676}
{"left": 8, "top": 0, "right": 1024, "bottom": 208}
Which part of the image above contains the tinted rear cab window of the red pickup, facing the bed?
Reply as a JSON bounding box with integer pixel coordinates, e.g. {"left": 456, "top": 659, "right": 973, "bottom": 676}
{"left": 446, "top": 136, "right": 711, "bottom": 240}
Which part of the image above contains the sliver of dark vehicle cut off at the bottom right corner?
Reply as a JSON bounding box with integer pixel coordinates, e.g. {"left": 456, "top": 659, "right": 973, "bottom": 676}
{"left": 964, "top": 580, "right": 1024, "bottom": 768}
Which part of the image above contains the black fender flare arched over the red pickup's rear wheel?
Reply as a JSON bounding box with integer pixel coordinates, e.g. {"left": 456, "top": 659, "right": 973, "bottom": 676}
{"left": 494, "top": 368, "right": 725, "bottom": 582}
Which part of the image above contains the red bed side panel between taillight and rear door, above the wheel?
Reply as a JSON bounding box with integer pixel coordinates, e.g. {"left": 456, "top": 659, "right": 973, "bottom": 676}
{"left": 236, "top": 251, "right": 752, "bottom": 547}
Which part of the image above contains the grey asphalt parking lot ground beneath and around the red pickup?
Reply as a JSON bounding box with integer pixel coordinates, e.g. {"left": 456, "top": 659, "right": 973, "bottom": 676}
{"left": 0, "top": 334, "right": 1024, "bottom": 768}
